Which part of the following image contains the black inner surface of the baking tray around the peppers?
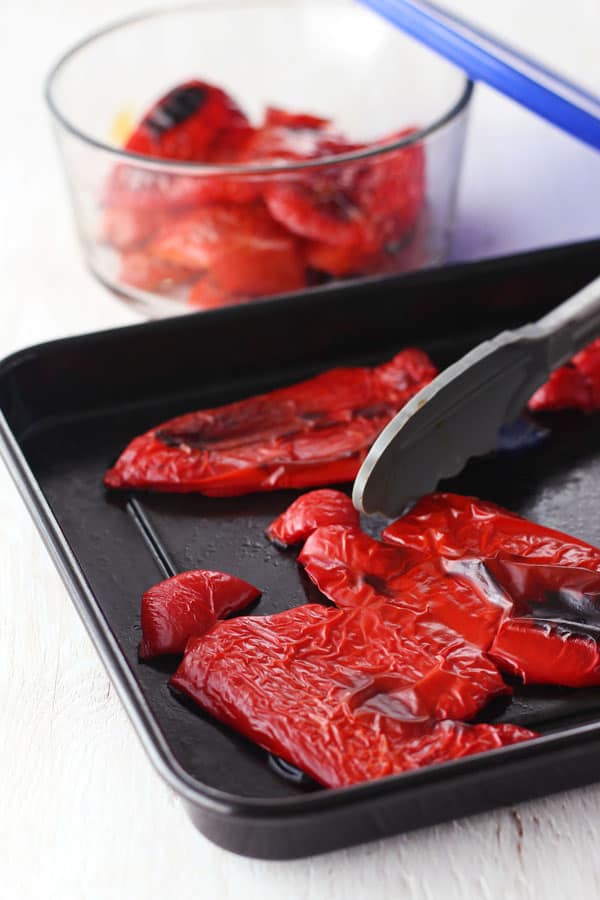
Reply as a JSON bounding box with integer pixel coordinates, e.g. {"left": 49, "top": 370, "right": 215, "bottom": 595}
{"left": 0, "top": 244, "right": 600, "bottom": 855}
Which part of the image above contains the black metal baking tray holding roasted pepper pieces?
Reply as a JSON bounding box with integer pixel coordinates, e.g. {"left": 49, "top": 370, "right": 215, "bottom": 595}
{"left": 0, "top": 241, "right": 600, "bottom": 859}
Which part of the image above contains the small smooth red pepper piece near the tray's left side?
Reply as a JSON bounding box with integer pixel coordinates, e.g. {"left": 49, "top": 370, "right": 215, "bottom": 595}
{"left": 140, "top": 569, "right": 260, "bottom": 659}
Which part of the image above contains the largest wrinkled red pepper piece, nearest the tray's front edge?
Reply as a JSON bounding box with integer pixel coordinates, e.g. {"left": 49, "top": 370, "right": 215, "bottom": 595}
{"left": 171, "top": 606, "right": 535, "bottom": 787}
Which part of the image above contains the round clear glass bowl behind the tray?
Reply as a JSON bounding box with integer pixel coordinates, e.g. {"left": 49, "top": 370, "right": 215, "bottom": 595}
{"left": 47, "top": 0, "right": 472, "bottom": 316}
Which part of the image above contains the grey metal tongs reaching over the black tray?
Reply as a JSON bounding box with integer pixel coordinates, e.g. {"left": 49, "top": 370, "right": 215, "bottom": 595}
{"left": 352, "top": 277, "right": 600, "bottom": 517}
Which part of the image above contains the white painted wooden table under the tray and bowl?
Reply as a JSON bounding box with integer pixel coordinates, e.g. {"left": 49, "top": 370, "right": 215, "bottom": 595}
{"left": 0, "top": 0, "right": 600, "bottom": 900}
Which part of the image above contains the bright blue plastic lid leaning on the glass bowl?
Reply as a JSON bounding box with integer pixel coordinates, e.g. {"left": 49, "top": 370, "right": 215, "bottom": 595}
{"left": 361, "top": 0, "right": 600, "bottom": 150}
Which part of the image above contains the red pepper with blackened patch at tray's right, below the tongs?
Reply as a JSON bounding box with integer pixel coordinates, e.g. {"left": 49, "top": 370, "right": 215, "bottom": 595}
{"left": 383, "top": 494, "right": 600, "bottom": 687}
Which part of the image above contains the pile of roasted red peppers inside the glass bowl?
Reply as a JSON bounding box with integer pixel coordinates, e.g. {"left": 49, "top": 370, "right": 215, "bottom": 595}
{"left": 101, "top": 80, "right": 428, "bottom": 309}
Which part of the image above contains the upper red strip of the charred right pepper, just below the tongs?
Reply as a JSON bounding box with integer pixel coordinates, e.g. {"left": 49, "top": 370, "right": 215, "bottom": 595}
{"left": 382, "top": 493, "right": 600, "bottom": 572}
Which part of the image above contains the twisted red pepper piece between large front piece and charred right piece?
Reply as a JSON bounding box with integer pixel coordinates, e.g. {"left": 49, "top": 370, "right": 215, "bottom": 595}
{"left": 298, "top": 525, "right": 512, "bottom": 650}
